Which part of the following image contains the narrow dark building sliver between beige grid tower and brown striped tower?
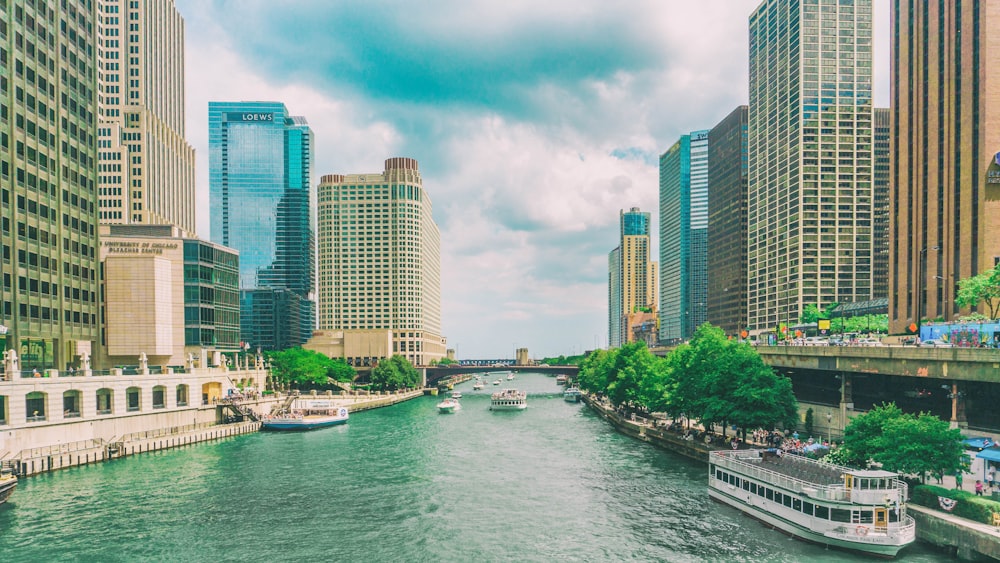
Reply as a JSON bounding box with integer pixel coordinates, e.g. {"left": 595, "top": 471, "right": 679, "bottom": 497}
{"left": 872, "top": 108, "right": 889, "bottom": 299}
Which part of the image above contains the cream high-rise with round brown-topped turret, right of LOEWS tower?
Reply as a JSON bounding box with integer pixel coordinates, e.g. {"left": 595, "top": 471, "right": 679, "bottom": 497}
{"left": 317, "top": 158, "right": 446, "bottom": 365}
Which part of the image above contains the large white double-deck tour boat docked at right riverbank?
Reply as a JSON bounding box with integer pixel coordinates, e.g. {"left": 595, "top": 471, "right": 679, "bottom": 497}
{"left": 708, "top": 450, "right": 916, "bottom": 557}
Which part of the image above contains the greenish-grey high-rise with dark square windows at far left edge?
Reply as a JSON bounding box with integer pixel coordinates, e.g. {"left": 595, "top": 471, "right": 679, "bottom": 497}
{"left": 0, "top": 0, "right": 100, "bottom": 370}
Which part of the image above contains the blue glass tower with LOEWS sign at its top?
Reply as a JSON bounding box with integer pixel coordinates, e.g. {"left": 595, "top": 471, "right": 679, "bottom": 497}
{"left": 208, "top": 102, "right": 315, "bottom": 350}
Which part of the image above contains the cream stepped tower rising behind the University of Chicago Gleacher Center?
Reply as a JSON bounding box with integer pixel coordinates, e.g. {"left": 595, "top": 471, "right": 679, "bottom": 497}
{"left": 97, "top": 0, "right": 197, "bottom": 233}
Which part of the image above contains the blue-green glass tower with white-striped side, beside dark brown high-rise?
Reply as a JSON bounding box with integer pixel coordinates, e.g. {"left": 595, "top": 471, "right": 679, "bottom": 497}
{"left": 660, "top": 131, "right": 709, "bottom": 343}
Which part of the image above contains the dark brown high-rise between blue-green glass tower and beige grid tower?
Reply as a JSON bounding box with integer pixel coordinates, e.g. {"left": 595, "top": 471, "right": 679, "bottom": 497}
{"left": 708, "top": 106, "right": 747, "bottom": 336}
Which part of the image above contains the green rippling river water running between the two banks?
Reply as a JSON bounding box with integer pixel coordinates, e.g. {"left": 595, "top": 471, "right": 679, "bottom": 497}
{"left": 0, "top": 374, "right": 948, "bottom": 562}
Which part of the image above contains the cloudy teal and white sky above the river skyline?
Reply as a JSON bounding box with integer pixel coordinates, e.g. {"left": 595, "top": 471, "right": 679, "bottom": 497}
{"left": 176, "top": 0, "right": 889, "bottom": 359}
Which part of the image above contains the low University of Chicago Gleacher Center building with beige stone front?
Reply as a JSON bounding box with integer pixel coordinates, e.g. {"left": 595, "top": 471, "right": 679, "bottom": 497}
{"left": 98, "top": 225, "right": 240, "bottom": 368}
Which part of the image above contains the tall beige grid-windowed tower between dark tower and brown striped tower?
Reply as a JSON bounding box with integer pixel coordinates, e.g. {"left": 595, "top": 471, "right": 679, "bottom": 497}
{"left": 747, "top": 0, "right": 873, "bottom": 332}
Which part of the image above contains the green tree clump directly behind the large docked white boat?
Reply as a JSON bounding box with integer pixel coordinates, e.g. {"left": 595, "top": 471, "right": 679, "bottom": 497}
{"left": 839, "top": 403, "right": 965, "bottom": 479}
